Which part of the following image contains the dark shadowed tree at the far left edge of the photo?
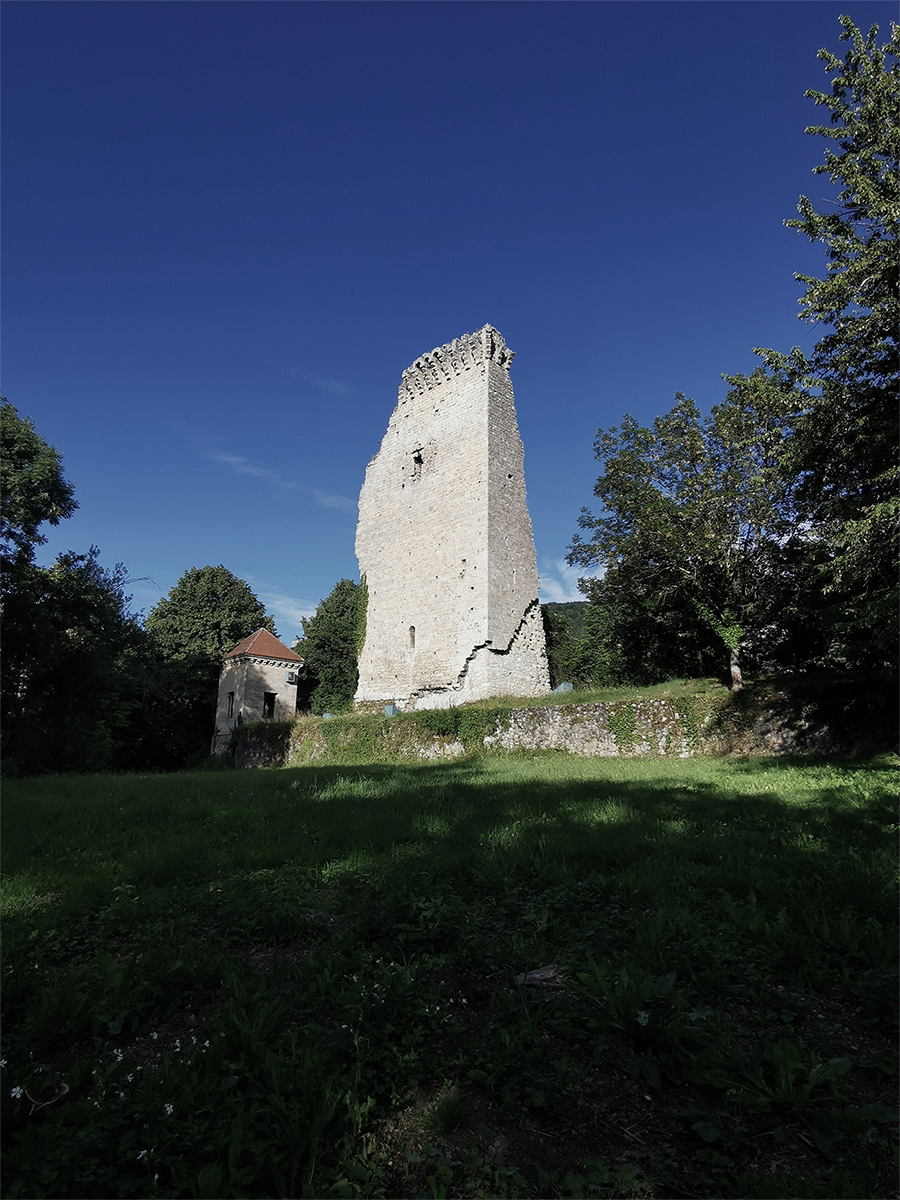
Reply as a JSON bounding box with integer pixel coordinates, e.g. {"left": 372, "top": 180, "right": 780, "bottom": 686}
{"left": 0, "top": 400, "right": 142, "bottom": 774}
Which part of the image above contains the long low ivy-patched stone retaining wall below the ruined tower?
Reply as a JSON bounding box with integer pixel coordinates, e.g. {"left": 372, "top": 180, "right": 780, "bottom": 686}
{"left": 230, "top": 679, "right": 898, "bottom": 766}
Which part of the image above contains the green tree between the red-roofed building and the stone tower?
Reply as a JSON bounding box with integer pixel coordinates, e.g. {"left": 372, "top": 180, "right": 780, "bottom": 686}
{"left": 301, "top": 578, "right": 368, "bottom": 713}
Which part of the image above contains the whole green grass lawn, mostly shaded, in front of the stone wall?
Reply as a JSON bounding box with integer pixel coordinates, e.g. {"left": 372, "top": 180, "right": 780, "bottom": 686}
{"left": 2, "top": 755, "right": 898, "bottom": 1198}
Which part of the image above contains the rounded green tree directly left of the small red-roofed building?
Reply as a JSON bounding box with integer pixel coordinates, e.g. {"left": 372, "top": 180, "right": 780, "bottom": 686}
{"left": 145, "top": 564, "right": 275, "bottom": 769}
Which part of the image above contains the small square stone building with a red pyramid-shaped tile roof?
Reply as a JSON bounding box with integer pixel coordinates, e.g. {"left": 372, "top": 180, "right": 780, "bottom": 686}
{"left": 212, "top": 629, "right": 304, "bottom": 754}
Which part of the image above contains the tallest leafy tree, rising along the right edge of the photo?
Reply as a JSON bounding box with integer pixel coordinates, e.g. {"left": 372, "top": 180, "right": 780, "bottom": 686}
{"left": 758, "top": 17, "right": 900, "bottom": 662}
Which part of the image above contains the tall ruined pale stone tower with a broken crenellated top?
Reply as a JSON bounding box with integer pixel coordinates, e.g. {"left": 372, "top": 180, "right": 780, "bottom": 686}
{"left": 356, "top": 325, "right": 550, "bottom": 708}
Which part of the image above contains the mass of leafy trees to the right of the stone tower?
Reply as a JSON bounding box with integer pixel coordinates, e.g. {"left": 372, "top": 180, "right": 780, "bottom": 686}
{"left": 564, "top": 17, "right": 900, "bottom": 688}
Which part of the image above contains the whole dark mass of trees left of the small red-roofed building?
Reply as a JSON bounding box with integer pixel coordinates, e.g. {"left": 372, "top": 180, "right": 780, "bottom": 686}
{"left": 0, "top": 401, "right": 282, "bottom": 776}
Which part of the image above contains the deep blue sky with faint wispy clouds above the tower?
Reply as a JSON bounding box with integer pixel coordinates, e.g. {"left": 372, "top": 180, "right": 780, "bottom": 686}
{"left": 2, "top": 0, "right": 895, "bottom": 642}
